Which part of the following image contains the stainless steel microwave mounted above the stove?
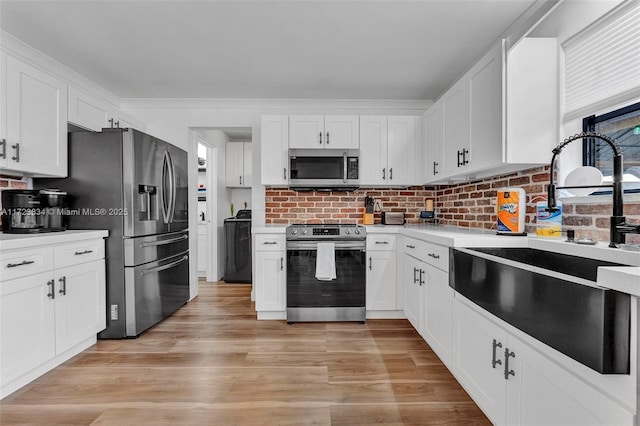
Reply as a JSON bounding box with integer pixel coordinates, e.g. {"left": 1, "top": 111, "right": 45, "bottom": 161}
{"left": 289, "top": 149, "right": 360, "bottom": 191}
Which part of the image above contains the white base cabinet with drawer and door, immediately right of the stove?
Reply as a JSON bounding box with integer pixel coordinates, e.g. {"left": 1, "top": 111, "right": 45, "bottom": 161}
{"left": 366, "top": 233, "right": 402, "bottom": 311}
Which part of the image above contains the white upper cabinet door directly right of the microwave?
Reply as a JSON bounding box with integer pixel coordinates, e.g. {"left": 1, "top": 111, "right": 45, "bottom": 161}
{"left": 360, "top": 115, "right": 388, "bottom": 186}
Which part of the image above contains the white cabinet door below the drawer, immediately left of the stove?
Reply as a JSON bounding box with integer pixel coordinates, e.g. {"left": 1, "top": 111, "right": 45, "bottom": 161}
{"left": 254, "top": 251, "right": 287, "bottom": 311}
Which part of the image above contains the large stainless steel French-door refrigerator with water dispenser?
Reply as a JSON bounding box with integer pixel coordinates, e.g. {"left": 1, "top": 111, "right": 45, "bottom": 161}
{"left": 34, "top": 129, "right": 189, "bottom": 339}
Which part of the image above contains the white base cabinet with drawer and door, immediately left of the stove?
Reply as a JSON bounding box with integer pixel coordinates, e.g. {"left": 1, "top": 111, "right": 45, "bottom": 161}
{"left": 253, "top": 234, "right": 287, "bottom": 319}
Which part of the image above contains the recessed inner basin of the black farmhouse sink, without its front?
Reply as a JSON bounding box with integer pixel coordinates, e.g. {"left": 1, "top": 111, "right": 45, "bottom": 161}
{"left": 469, "top": 247, "right": 627, "bottom": 282}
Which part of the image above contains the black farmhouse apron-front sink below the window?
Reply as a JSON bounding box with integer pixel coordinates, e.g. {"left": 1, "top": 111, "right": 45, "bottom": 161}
{"left": 449, "top": 248, "right": 631, "bottom": 374}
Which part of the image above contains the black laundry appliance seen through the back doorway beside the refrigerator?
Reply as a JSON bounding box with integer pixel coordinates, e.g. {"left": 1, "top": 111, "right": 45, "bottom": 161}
{"left": 224, "top": 210, "right": 251, "bottom": 283}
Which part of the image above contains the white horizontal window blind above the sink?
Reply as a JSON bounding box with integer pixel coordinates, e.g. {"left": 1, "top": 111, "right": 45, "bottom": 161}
{"left": 562, "top": 0, "right": 640, "bottom": 114}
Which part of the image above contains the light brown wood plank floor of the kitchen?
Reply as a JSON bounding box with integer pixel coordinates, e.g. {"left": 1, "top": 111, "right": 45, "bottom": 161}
{"left": 0, "top": 281, "right": 490, "bottom": 425}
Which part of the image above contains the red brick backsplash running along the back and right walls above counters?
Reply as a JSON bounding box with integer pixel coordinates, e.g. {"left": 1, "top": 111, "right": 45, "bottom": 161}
{"left": 265, "top": 166, "right": 640, "bottom": 244}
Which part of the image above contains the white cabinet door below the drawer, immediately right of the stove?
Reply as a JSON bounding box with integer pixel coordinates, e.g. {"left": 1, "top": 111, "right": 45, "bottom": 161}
{"left": 367, "top": 250, "right": 398, "bottom": 311}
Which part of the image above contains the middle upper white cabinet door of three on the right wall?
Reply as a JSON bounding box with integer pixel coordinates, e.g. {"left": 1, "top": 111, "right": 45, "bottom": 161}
{"left": 441, "top": 77, "right": 470, "bottom": 177}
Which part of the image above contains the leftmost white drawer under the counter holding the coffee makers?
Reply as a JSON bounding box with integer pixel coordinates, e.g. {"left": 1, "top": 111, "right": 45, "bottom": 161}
{"left": 0, "top": 247, "right": 53, "bottom": 281}
